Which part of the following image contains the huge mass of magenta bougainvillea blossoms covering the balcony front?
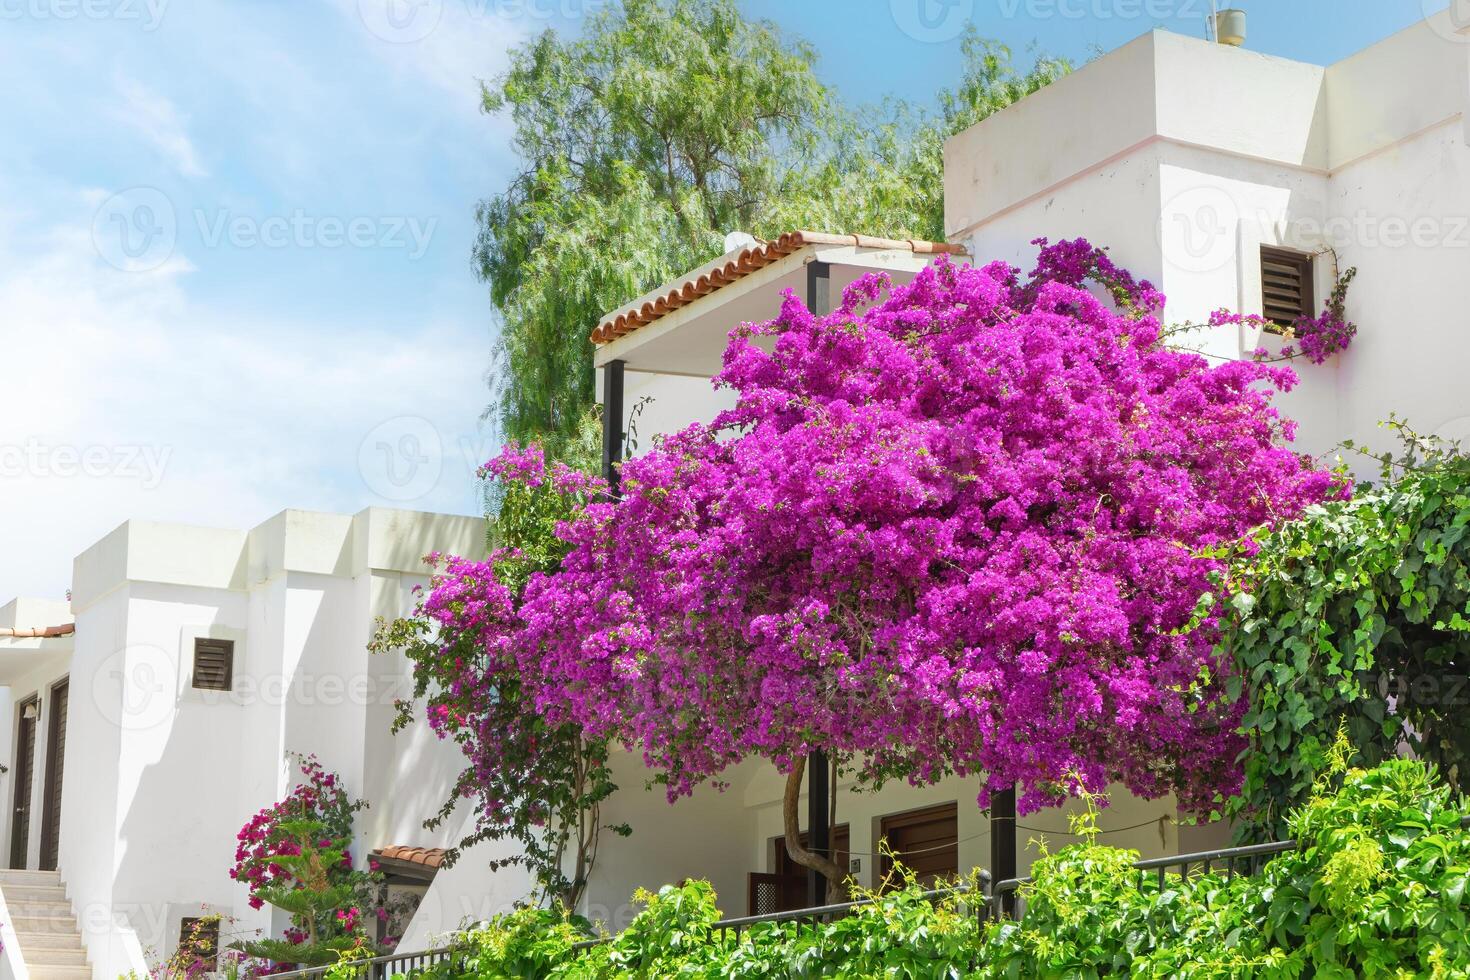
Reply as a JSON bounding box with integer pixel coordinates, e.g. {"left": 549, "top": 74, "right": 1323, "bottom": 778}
{"left": 426, "top": 241, "right": 1345, "bottom": 813}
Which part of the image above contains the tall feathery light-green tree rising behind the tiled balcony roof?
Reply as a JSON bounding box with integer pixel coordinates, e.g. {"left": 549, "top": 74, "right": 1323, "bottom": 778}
{"left": 475, "top": 0, "right": 1069, "bottom": 458}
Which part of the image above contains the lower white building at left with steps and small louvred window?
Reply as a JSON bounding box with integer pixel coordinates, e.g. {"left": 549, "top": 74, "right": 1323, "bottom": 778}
{"left": 0, "top": 508, "right": 485, "bottom": 980}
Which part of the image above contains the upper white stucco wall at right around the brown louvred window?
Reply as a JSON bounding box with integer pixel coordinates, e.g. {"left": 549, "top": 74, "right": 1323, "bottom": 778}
{"left": 945, "top": 13, "right": 1470, "bottom": 470}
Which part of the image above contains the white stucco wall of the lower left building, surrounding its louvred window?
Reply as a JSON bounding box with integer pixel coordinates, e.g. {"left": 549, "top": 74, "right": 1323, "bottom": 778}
{"left": 60, "top": 510, "right": 484, "bottom": 977}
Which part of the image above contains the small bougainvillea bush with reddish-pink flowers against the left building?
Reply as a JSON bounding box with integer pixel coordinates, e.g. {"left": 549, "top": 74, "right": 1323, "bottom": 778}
{"left": 229, "top": 755, "right": 384, "bottom": 973}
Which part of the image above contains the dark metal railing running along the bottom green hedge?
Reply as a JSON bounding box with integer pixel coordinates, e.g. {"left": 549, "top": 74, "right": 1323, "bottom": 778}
{"left": 258, "top": 815, "right": 1470, "bottom": 980}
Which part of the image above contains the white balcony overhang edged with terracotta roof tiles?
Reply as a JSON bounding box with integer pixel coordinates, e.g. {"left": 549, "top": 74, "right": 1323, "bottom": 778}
{"left": 592, "top": 232, "right": 967, "bottom": 378}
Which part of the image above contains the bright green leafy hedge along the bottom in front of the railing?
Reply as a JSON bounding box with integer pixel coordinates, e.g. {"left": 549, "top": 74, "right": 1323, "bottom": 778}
{"left": 370, "top": 760, "right": 1470, "bottom": 980}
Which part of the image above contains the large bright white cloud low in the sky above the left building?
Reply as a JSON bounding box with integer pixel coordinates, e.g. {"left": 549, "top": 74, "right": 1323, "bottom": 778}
{"left": 0, "top": 205, "right": 488, "bottom": 601}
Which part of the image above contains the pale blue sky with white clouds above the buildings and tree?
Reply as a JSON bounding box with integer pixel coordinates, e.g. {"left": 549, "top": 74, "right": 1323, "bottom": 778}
{"left": 0, "top": 0, "right": 1445, "bottom": 602}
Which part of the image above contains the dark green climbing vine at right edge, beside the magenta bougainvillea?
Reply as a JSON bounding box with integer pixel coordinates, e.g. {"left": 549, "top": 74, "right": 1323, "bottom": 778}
{"left": 1222, "top": 420, "right": 1470, "bottom": 837}
